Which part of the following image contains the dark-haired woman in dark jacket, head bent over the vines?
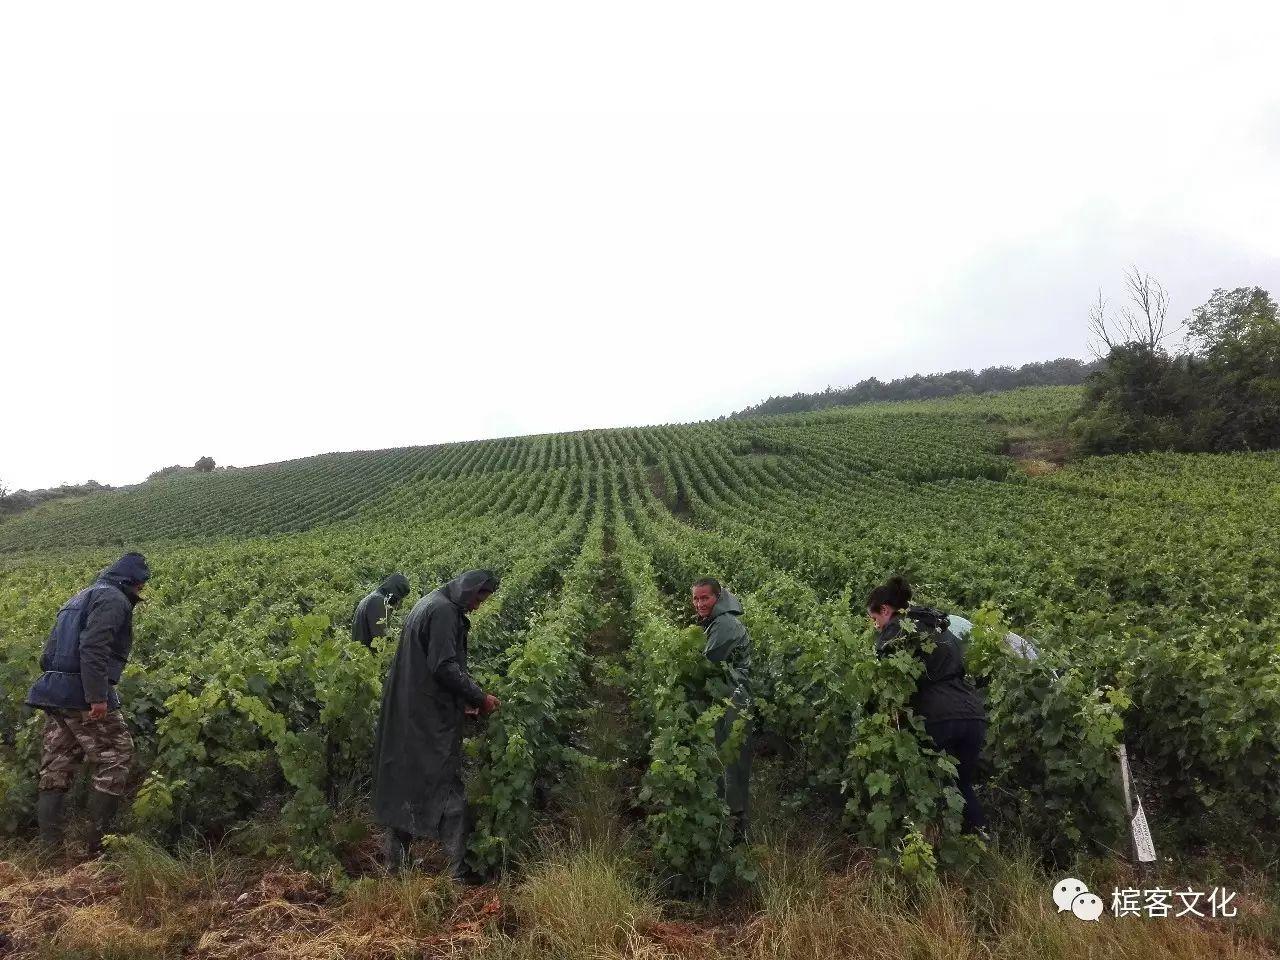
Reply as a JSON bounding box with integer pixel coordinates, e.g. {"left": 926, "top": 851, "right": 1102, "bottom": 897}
{"left": 867, "top": 577, "right": 987, "bottom": 833}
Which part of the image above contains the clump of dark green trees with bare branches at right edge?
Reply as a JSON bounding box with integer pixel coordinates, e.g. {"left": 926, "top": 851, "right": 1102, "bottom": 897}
{"left": 1073, "top": 268, "right": 1280, "bottom": 453}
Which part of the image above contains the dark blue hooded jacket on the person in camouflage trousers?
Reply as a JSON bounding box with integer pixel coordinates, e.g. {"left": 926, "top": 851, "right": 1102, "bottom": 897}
{"left": 27, "top": 553, "right": 151, "bottom": 710}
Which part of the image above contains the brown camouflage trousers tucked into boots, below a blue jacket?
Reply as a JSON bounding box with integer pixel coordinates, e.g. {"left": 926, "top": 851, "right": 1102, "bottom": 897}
{"left": 40, "top": 710, "right": 133, "bottom": 796}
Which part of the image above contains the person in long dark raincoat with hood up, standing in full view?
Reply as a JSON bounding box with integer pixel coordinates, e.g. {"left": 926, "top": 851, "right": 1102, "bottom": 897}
{"left": 374, "top": 570, "right": 500, "bottom": 881}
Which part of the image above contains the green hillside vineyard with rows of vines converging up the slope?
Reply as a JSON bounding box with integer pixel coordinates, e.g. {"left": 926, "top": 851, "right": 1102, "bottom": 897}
{"left": 0, "top": 388, "right": 1280, "bottom": 887}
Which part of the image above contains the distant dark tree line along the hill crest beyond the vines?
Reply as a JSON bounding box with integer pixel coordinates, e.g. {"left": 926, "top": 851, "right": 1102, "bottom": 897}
{"left": 732, "top": 357, "right": 1101, "bottom": 420}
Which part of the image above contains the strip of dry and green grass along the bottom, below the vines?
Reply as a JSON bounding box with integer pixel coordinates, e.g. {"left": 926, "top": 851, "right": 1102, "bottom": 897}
{"left": 0, "top": 835, "right": 1280, "bottom": 960}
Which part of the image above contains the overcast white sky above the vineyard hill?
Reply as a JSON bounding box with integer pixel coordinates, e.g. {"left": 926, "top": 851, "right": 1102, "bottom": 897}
{"left": 0, "top": 0, "right": 1280, "bottom": 488}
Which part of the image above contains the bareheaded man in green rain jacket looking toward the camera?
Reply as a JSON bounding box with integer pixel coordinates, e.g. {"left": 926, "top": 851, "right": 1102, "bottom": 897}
{"left": 692, "top": 577, "right": 751, "bottom": 844}
